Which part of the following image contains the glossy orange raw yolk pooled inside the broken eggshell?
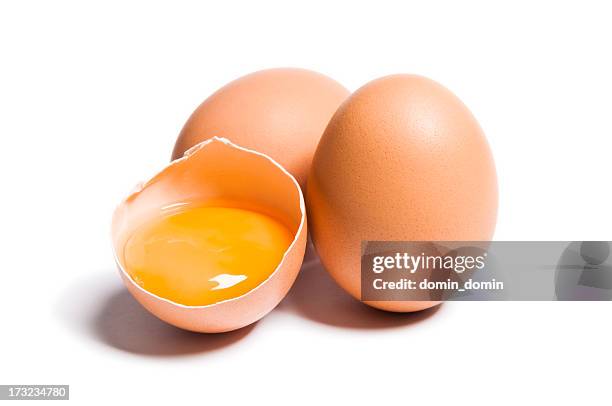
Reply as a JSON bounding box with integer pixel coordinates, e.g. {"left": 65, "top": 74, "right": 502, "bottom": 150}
{"left": 124, "top": 207, "right": 293, "bottom": 306}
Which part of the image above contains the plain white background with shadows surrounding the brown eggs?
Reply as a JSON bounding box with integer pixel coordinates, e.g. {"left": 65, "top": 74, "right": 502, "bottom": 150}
{"left": 0, "top": 0, "right": 612, "bottom": 405}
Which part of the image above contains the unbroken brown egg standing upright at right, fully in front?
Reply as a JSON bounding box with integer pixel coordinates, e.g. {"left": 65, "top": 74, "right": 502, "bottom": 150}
{"left": 306, "top": 75, "right": 497, "bottom": 312}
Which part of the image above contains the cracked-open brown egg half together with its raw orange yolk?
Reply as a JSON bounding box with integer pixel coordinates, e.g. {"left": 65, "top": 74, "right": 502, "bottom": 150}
{"left": 112, "top": 137, "right": 307, "bottom": 333}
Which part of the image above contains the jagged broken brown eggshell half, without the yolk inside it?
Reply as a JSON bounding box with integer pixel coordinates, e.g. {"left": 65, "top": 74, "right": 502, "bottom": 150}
{"left": 112, "top": 137, "right": 307, "bottom": 333}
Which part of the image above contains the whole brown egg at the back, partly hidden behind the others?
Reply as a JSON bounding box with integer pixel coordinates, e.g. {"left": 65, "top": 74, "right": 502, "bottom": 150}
{"left": 172, "top": 68, "right": 349, "bottom": 186}
